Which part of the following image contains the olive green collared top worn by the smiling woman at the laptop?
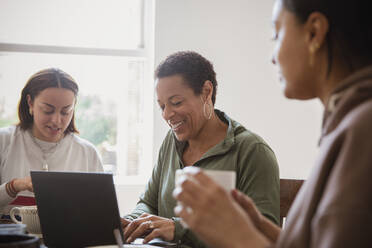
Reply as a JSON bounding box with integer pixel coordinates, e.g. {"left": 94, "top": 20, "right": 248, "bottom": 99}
{"left": 125, "top": 110, "right": 280, "bottom": 247}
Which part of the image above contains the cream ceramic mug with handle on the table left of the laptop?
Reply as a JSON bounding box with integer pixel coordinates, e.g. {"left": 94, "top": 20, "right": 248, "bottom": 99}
{"left": 9, "top": 206, "right": 41, "bottom": 234}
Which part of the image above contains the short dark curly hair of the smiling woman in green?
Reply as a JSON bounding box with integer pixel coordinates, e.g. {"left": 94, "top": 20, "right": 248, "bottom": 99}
{"left": 155, "top": 51, "right": 217, "bottom": 105}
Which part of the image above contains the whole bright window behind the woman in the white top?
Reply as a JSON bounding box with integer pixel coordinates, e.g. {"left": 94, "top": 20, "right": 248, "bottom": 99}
{"left": 0, "top": 0, "right": 153, "bottom": 183}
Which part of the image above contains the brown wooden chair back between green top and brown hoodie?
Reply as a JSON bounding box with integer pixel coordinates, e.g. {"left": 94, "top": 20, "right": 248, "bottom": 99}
{"left": 280, "top": 179, "right": 304, "bottom": 227}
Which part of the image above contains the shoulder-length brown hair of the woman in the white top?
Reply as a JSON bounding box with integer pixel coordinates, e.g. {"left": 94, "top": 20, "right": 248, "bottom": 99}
{"left": 18, "top": 68, "right": 79, "bottom": 134}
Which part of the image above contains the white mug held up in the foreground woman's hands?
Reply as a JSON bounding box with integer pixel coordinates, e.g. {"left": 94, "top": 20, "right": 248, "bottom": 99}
{"left": 175, "top": 169, "right": 236, "bottom": 228}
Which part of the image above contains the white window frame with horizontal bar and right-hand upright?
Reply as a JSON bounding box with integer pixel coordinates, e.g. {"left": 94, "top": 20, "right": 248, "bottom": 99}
{"left": 0, "top": 0, "right": 155, "bottom": 185}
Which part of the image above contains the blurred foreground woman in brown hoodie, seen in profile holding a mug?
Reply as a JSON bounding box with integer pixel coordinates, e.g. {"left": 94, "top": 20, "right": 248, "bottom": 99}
{"left": 174, "top": 0, "right": 372, "bottom": 248}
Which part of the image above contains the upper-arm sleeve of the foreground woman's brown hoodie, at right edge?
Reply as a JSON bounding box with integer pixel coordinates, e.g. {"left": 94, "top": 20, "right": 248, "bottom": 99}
{"left": 309, "top": 107, "right": 372, "bottom": 248}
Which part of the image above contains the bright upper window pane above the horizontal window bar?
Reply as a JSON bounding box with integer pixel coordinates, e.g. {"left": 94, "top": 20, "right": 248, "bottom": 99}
{"left": 0, "top": 0, "right": 143, "bottom": 49}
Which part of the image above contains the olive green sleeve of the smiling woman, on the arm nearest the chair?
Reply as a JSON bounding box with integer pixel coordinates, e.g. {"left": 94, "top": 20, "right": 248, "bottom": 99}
{"left": 237, "top": 142, "right": 280, "bottom": 224}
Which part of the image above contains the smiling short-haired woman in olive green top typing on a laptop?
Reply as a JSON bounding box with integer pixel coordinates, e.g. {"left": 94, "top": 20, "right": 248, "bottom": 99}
{"left": 122, "top": 51, "right": 279, "bottom": 247}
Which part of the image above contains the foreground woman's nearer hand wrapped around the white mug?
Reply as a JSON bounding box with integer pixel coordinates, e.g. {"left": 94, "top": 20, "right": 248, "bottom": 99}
{"left": 173, "top": 167, "right": 268, "bottom": 247}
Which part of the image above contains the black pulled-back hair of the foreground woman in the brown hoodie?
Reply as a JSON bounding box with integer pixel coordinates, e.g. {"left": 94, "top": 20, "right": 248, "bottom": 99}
{"left": 280, "top": 0, "right": 372, "bottom": 73}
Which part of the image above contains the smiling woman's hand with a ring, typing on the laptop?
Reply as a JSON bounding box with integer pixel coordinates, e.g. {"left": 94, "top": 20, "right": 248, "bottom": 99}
{"left": 122, "top": 213, "right": 175, "bottom": 243}
